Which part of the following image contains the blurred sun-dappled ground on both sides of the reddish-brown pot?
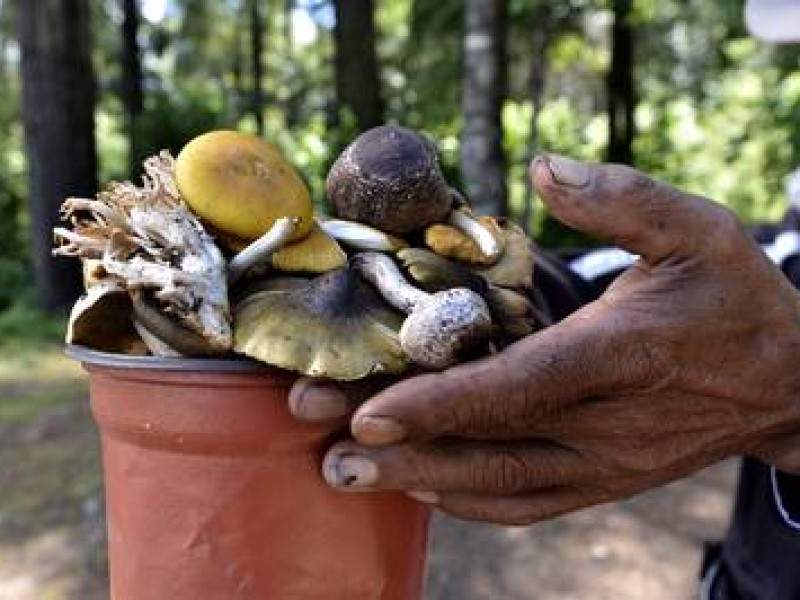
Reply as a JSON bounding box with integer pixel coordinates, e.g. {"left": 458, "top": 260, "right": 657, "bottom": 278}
{"left": 0, "top": 348, "right": 736, "bottom": 600}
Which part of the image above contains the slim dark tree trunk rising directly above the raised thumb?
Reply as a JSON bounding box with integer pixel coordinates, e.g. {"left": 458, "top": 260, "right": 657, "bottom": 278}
{"left": 606, "top": 0, "right": 636, "bottom": 165}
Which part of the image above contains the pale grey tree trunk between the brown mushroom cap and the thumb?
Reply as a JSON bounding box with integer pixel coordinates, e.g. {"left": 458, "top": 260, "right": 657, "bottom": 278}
{"left": 461, "top": 0, "right": 508, "bottom": 216}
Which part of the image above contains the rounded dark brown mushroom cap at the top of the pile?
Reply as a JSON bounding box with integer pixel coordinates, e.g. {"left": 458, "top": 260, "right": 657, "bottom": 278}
{"left": 326, "top": 125, "right": 453, "bottom": 235}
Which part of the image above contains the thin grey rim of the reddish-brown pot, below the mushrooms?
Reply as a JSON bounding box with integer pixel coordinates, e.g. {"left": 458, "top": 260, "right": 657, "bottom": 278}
{"left": 64, "top": 344, "right": 270, "bottom": 373}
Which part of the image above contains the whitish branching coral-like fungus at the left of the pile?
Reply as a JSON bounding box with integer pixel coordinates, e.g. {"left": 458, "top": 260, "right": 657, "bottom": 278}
{"left": 53, "top": 152, "right": 232, "bottom": 354}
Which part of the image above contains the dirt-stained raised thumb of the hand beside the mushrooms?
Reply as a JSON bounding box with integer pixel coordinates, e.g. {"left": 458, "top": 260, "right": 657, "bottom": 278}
{"left": 530, "top": 155, "right": 727, "bottom": 264}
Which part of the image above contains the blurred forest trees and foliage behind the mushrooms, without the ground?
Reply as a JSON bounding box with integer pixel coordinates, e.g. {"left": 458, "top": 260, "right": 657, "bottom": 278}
{"left": 0, "top": 0, "right": 800, "bottom": 316}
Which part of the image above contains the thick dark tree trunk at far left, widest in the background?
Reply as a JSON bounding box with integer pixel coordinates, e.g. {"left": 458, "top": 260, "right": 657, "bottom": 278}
{"left": 15, "top": 0, "right": 97, "bottom": 310}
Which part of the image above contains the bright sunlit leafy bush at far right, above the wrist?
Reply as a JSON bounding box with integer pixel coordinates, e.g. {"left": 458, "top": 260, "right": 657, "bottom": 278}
{"left": 636, "top": 39, "right": 800, "bottom": 221}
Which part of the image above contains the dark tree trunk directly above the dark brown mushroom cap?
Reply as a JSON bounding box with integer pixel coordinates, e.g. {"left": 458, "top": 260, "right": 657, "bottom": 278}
{"left": 334, "top": 0, "right": 383, "bottom": 131}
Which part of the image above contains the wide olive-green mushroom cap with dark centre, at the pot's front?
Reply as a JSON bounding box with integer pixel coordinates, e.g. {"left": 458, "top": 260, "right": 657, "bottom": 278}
{"left": 233, "top": 267, "right": 408, "bottom": 381}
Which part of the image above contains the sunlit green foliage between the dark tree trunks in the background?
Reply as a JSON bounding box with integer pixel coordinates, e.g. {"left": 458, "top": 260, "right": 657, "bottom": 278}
{"left": 0, "top": 0, "right": 800, "bottom": 318}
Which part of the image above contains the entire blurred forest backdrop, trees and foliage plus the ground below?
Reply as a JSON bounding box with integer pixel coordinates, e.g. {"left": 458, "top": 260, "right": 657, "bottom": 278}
{"left": 0, "top": 0, "right": 800, "bottom": 600}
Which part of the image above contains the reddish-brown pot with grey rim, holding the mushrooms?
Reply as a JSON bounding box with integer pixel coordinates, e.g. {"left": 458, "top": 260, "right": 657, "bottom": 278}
{"left": 69, "top": 347, "right": 429, "bottom": 600}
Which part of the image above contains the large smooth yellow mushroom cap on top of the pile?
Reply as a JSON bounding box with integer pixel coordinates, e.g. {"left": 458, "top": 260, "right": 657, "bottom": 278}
{"left": 175, "top": 130, "right": 313, "bottom": 240}
